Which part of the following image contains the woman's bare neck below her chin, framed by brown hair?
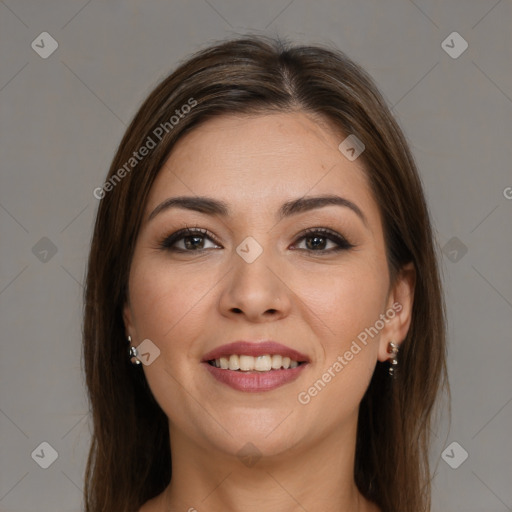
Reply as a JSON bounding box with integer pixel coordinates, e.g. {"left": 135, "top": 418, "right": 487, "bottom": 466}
{"left": 160, "top": 418, "right": 378, "bottom": 512}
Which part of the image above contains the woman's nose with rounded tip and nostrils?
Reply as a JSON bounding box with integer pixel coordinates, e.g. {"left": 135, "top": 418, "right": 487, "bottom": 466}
{"left": 219, "top": 245, "right": 292, "bottom": 323}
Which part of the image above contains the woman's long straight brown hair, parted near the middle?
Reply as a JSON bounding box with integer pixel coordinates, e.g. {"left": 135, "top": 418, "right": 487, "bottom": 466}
{"left": 83, "top": 36, "right": 448, "bottom": 512}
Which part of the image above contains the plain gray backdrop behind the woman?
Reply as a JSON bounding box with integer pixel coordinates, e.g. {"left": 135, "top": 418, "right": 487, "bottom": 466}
{"left": 0, "top": 0, "right": 512, "bottom": 512}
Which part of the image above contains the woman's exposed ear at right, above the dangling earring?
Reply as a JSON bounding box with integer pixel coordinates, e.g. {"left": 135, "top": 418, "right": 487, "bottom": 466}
{"left": 378, "top": 263, "right": 416, "bottom": 361}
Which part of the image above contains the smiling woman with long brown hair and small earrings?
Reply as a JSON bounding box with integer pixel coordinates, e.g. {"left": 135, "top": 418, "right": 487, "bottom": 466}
{"left": 84, "top": 37, "right": 446, "bottom": 512}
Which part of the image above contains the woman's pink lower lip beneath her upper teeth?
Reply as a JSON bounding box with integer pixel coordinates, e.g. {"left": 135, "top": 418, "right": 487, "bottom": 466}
{"left": 202, "top": 363, "right": 307, "bottom": 393}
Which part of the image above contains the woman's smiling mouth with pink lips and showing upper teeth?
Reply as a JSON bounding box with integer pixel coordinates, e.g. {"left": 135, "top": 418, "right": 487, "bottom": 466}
{"left": 201, "top": 341, "right": 310, "bottom": 392}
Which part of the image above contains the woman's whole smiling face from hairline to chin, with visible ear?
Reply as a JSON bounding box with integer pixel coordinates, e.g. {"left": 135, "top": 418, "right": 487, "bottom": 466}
{"left": 124, "top": 113, "right": 412, "bottom": 457}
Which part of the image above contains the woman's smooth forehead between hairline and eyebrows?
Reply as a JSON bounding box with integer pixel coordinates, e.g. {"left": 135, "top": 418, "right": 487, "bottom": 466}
{"left": 147, "top": 112, "right": 378, "bottom": 223}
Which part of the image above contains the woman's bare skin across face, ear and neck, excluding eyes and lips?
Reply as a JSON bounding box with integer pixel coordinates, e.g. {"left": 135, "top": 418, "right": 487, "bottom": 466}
{"left": 124, "top": 112, "right": 414, "bottom": 512}
